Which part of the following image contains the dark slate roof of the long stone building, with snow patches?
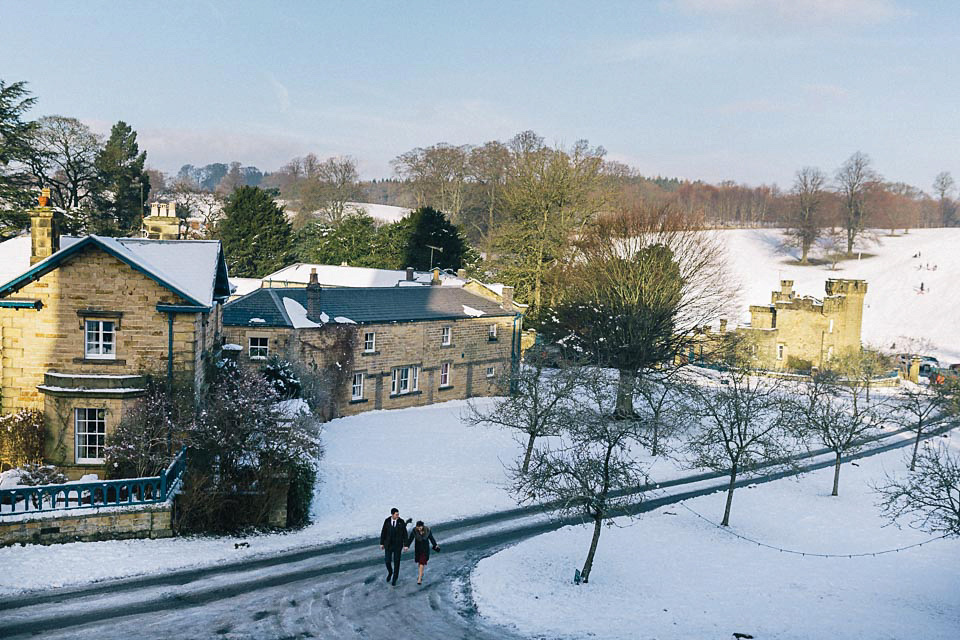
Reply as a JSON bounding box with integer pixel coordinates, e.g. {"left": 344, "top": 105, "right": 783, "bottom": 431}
{"left": 223, "top": 287, "right": 515, "bottom": 327}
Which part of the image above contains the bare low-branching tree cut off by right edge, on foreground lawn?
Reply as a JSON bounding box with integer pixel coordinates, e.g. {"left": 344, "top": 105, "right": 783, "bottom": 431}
{"left": 875, "top": 443, "right": 960, "bottom": 536}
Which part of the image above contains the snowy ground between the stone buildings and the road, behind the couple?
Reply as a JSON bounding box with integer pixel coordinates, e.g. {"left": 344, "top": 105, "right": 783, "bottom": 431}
{"left": 0, "top": 398, "right": 680, "bottom": 594}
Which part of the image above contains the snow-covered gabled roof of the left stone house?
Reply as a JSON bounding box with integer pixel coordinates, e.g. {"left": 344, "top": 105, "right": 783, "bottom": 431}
{"left": 0, "top": 235, "right": 230, "bottom": 307}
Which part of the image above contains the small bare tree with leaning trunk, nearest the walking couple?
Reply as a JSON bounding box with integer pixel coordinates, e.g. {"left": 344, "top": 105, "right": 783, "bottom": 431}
{"left": 511, "top": 370, "right": 647, "bottom": 583}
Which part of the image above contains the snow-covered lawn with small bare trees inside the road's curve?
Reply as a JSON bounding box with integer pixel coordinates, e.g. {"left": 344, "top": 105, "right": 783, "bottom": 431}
{"left": 471, "top": 435, "right": 960, "bottom": 640}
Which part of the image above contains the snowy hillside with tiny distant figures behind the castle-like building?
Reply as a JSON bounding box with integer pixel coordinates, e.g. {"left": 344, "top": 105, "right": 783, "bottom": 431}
{"left": 721, "top": 228, "right": 960, "bottom": 363}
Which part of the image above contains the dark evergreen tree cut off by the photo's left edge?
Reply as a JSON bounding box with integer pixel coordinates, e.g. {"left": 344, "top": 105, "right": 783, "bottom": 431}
{"left": 0, "top": 80, "right": 37, "bottom": 237}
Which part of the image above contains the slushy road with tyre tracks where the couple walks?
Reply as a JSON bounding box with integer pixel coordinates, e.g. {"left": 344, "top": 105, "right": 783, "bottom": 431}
{"left": 0, "top": 420, "right": 952, "bottom": 640}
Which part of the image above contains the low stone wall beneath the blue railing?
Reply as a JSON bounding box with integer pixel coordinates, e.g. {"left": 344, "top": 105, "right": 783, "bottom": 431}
{"left": 0, "top": 504, "right": 173, "bottom": 546}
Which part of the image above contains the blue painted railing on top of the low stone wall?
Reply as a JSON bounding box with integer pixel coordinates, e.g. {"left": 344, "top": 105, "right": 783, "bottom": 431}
{"left": 0, "top": 447, "right": 187, "bottom": 520}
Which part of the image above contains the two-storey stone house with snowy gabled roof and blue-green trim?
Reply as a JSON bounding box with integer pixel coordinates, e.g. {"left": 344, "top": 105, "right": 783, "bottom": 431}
{"left": 0, "top": 192, "right": 229, "bottom": 478}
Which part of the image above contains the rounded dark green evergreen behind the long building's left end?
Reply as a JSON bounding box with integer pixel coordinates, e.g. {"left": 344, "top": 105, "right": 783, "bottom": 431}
{"left": 217, "top": 186, "right": 293, "bottom": 278}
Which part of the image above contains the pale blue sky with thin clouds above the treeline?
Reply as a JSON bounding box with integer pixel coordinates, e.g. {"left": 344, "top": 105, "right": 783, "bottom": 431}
{"left": 0, "top": 0, "right": 960, "bottom": 191}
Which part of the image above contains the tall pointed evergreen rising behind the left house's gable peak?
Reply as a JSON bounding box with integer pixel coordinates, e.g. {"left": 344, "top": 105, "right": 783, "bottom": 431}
{"left": 90, "top": 120, "right": 150, "bottom": 235}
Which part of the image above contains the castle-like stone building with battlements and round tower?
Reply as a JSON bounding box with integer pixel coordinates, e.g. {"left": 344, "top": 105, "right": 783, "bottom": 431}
{"left": 740, "top": 279, "right": 867, "bottom": 370}
